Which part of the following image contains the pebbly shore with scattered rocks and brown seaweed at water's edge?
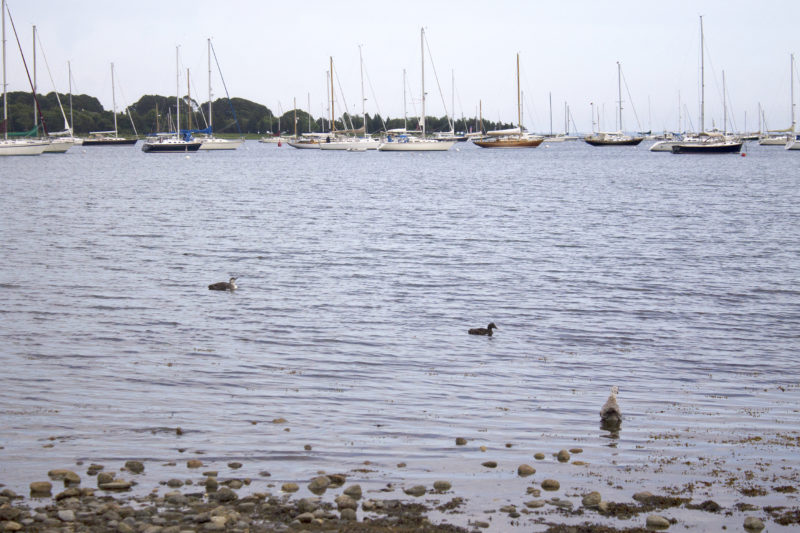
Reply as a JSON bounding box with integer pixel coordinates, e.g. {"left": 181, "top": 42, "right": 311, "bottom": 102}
{"left": 0, "top": 439, "right": 800, "bottom": 533}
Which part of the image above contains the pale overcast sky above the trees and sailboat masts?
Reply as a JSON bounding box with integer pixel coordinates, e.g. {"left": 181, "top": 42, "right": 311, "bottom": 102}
{"left": 1, "top": 0, "right": 800, "bottom": 132}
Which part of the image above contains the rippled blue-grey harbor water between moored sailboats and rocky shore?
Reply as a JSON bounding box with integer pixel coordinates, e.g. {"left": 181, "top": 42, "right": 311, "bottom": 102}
{"left": 0, "top": 142, "right": 800, "bottom": 531}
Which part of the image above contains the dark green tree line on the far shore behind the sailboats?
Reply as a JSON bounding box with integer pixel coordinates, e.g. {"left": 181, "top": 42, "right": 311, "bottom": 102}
{"left": 0, "top": 91, "right": 513, "bottom": 136}
